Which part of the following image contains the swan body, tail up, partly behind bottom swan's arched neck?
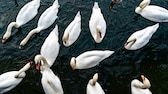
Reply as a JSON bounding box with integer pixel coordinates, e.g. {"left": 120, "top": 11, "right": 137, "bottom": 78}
{"left": 40, "top": 25, "right": 60, "bottom": 67}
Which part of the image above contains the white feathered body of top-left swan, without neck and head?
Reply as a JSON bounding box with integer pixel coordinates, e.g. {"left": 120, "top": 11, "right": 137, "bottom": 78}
{"left": 16, "top": 0, "right": 40, "bottom": 26}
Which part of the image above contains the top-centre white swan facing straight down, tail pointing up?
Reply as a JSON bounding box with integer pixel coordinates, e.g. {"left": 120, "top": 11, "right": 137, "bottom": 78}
{"left": 89, "top": 2, "right": 106, "bottom": 43}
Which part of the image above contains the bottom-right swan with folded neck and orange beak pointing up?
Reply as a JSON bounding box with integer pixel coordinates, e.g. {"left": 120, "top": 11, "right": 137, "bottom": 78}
{"left": 131, "top": 75, "right": 152, "bottom": 94}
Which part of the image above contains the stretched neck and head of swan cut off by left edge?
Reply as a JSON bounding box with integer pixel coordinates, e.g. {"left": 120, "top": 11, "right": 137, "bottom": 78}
{"left": 15, "top": 62, "right": 32, "bottom": 78}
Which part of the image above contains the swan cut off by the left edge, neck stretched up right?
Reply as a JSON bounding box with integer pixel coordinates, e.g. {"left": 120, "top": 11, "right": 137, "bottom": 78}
{"left": 0, "top": 62, "right": 32, "bottom": 94}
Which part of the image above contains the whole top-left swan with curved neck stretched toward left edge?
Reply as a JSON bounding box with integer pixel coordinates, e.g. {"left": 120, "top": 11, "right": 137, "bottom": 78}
{"left": 2, "top": 0, "right": 40, "bottom": 43}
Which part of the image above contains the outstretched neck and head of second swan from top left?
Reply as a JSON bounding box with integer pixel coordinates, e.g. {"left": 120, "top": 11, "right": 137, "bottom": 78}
{"left": 19, "top": 28, "right": 40, "bottom": 48}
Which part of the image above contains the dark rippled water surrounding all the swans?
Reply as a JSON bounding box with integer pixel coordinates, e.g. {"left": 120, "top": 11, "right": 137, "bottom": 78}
{"left": 0, "top": 0, "right": 168, "bottom": 94}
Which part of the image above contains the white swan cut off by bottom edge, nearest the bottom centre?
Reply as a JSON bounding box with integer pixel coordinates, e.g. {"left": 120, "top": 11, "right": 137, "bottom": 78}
{"left": 86, "top": 73, "right": 105, "bottom": 94}
